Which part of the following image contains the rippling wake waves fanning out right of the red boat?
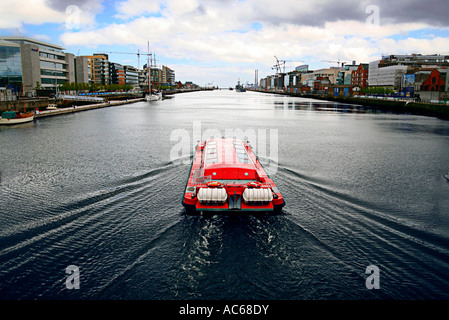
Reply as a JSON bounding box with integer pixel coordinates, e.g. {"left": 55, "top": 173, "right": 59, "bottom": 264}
{"left": 275, "top": 167, "right": 449, "bottom": 298}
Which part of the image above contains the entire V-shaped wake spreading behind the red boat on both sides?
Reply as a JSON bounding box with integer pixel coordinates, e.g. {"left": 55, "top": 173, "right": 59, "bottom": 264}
{"left": 0, "top": 159, "right": 449, "bottom": 299}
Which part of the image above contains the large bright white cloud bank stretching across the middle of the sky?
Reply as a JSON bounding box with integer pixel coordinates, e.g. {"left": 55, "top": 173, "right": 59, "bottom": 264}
{"left": 61, "top": 0, "right": 445, "bottom": 71}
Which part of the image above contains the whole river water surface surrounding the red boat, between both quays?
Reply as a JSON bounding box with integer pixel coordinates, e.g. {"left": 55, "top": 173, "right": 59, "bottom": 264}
{"left": 0, "top": 90, "right": 449, "bottom": 300}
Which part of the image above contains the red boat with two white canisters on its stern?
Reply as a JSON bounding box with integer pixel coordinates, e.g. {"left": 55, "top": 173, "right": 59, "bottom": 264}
{"left": 182, "top": 138, "right": 285, "bottom": 214}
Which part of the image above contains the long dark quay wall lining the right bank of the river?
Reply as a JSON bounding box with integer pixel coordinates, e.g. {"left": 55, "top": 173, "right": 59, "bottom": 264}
{"left": 252, "top": 91, "right": 449, "bottom": 120}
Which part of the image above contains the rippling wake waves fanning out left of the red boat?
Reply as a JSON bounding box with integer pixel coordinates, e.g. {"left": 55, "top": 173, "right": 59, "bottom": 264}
{"left": 0, "top": 162, "right": 183, "bottom": 298}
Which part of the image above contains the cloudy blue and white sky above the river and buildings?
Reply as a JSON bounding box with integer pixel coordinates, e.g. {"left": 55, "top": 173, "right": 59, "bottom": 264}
{"left": 0, "top": 0, "right": 449, "bottom": 87}
